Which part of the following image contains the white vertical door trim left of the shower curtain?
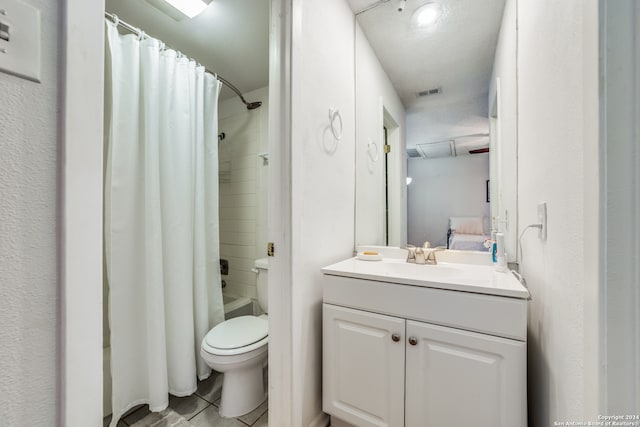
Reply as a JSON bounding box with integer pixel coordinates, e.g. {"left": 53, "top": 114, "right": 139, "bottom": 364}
{"left": 57, "top": 0, "right": 104, "bottom": 427}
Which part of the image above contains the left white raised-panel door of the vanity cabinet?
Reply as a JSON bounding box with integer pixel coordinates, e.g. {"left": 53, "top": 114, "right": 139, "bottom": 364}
{"left": 322, "top": 304, "right": 405, "bottom": 427}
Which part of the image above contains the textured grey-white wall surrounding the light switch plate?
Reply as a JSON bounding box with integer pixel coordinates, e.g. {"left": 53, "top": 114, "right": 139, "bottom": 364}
{"left": 0, "top": 0, "right": 59, "bottom": 426}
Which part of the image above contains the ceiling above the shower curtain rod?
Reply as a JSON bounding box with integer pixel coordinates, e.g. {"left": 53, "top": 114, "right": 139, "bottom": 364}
{"left": 105, "top": 0, "right": 269, "bottom": 101}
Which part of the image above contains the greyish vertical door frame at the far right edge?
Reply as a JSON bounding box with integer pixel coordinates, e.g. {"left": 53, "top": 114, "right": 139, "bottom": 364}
{"left": 596, "top": 0, "right": 640, "bottom": 414}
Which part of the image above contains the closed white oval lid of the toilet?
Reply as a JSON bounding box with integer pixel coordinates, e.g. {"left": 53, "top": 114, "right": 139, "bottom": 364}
{"left": 204, "top": 316, "right": 269, "bottom": 349}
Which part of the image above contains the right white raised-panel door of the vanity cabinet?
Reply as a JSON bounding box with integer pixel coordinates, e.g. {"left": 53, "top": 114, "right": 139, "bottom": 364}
{"left": 405, "top": 320, "right": 527, "bottom": 427}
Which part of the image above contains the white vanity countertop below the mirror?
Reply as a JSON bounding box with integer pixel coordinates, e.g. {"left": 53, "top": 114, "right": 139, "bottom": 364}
{"left": 322, "top": 258, "right": 529, "bottom": 299}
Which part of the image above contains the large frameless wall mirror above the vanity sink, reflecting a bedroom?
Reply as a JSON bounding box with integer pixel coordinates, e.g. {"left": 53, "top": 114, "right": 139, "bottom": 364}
{"left": 349, "top": 0, "right": 517, "bottom": 261}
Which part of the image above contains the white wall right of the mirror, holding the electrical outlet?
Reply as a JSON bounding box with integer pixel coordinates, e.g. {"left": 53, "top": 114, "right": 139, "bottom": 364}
{"left": 518, "top": 0, "right": 598, "bottom": 427}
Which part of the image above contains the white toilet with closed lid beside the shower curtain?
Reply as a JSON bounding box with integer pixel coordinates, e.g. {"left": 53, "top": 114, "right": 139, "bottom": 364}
{"left": 200, "top": 258, "right": 269, "bottom": 417}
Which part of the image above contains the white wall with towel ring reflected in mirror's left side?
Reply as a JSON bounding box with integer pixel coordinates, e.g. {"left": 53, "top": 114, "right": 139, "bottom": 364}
{"left": 355, "top": 24, "right": 406, "bottom": 245}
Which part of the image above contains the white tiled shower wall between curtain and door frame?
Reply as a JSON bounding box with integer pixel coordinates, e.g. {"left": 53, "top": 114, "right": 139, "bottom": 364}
{"left": 218, "top": 87, "right": 269, "bottom": 299}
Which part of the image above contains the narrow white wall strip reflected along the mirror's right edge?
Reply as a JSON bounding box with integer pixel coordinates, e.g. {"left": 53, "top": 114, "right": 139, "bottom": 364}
{"left": 488, "top": 0, "right": 518, "bottom": 261}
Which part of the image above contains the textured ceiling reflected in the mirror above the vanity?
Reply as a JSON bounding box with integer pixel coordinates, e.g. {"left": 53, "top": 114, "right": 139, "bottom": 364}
{"left": 348, "top": 0, "right": 505, "bottom": 148}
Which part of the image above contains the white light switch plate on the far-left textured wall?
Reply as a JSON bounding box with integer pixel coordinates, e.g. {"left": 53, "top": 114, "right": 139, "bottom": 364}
{"left": 0, "top": 0, "right": 40, "bottom": 83}
